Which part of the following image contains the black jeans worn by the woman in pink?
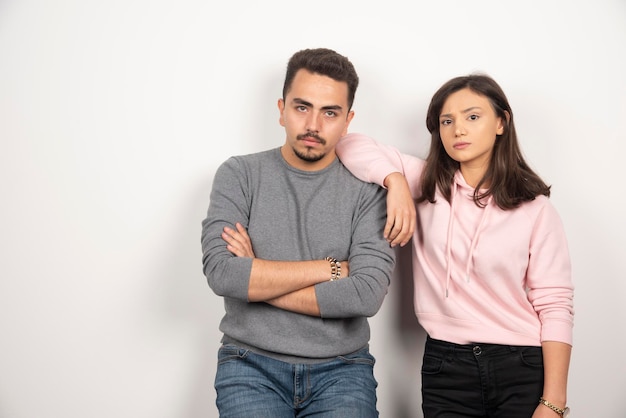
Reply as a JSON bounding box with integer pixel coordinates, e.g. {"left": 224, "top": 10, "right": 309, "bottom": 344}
{"left": 422, "top": 337, "right": 540, "bottom": 418}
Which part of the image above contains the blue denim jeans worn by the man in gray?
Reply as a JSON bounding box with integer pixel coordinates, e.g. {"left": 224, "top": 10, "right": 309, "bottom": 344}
{"left": 215, "top": 344, "right": 378, "bottom": 418}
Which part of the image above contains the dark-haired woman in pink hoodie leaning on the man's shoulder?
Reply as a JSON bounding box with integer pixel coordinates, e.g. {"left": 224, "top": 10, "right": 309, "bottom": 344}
{"left": 337, "top": 75, "right": 573, "bottom": 418}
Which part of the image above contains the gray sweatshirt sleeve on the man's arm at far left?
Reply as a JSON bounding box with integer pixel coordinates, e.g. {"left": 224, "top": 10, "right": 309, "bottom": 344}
{"left": 201, "top": 157, "right": 252, "bottom": 301}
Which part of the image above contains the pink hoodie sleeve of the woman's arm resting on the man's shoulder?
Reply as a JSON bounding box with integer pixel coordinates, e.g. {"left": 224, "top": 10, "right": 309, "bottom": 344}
{"left": 336, "top": 133, "right": 424, "bottom": 198}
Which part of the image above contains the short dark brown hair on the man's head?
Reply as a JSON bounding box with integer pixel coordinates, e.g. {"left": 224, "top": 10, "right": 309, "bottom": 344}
{"left": 283, "top": 48, "right": 359, "bottom": 110}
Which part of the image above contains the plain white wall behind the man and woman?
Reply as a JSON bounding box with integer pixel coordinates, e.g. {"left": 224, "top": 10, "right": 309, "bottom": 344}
{"left": 0, "top": 0, "right": 626, "bottom": 418}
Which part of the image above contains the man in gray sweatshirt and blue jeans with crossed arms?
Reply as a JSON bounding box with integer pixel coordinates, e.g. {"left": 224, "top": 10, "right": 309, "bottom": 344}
{"left": 202, "top": 49, "right": 395, "bottom": 418}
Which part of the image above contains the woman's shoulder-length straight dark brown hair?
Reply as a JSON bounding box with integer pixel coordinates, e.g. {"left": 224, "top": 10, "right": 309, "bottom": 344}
{"left": 417, "top": 74, "right": 550, "bottom": 210}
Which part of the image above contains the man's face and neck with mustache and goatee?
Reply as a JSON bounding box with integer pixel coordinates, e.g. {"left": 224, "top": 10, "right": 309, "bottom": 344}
{"left": 278, "top": 70, "right": 354, "bottom": 170}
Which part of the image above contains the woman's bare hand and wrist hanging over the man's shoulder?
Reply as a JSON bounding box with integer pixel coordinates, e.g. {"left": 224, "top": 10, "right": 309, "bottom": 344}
{"left": 384, "top": 173, "right": 417, "bottom": 247}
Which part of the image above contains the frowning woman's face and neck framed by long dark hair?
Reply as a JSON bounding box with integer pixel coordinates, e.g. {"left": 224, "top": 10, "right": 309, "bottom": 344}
{"left": 439, "top": 88, "right": 504, "bottom": 180}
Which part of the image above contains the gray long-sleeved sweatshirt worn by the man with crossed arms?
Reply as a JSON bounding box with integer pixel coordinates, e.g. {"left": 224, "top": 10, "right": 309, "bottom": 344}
{"left": 202, "top": 148, "right": 395, "bottom": 362}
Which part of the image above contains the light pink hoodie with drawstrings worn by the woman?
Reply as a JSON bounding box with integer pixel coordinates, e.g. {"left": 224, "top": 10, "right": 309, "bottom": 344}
{"left": 337, "top": 134, "right": 574, "bottom": 346}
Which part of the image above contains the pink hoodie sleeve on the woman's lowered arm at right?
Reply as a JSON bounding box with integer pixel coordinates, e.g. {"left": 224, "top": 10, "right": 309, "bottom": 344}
{"left": 527, "top": 198, "right": 574, "bottom": 345}
